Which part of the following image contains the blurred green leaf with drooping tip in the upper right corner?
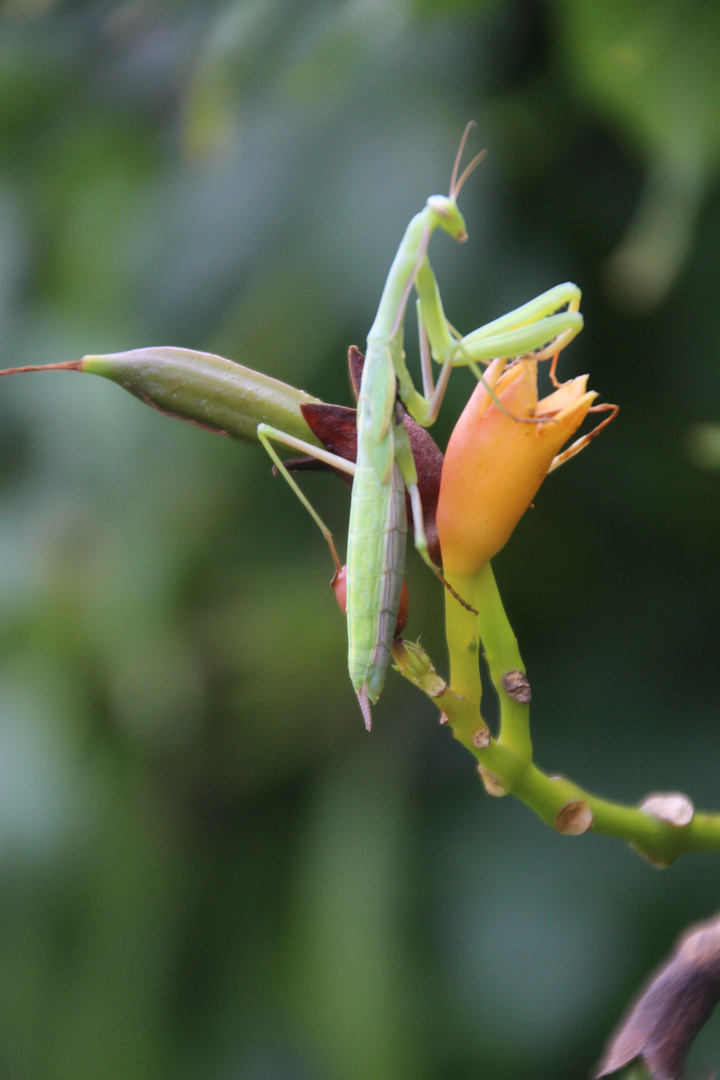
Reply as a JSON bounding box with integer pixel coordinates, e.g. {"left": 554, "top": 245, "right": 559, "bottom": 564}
{"left": 561, "top": 0, "right": 720, "bottom": 308}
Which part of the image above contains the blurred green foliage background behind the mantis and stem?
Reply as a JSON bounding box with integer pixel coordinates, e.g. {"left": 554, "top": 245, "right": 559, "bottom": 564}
{"left": 0, "top": 0, "right": 720, "bottom": 1080}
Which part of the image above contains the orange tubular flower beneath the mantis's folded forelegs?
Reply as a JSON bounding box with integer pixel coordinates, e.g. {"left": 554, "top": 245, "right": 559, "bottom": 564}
{"left": 437, "top": 360, "right": 597, "bottom": 577}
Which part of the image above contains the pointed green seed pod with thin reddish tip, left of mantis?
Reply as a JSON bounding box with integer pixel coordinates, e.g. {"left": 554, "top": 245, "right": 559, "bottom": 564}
{"left": 0, "top": 346, "right": 321, "bottom": 446}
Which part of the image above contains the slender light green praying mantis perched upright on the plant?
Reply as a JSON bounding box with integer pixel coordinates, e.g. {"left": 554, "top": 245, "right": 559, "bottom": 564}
{"left": 257, "top": 123, "right": 583, "bottom": 730}
